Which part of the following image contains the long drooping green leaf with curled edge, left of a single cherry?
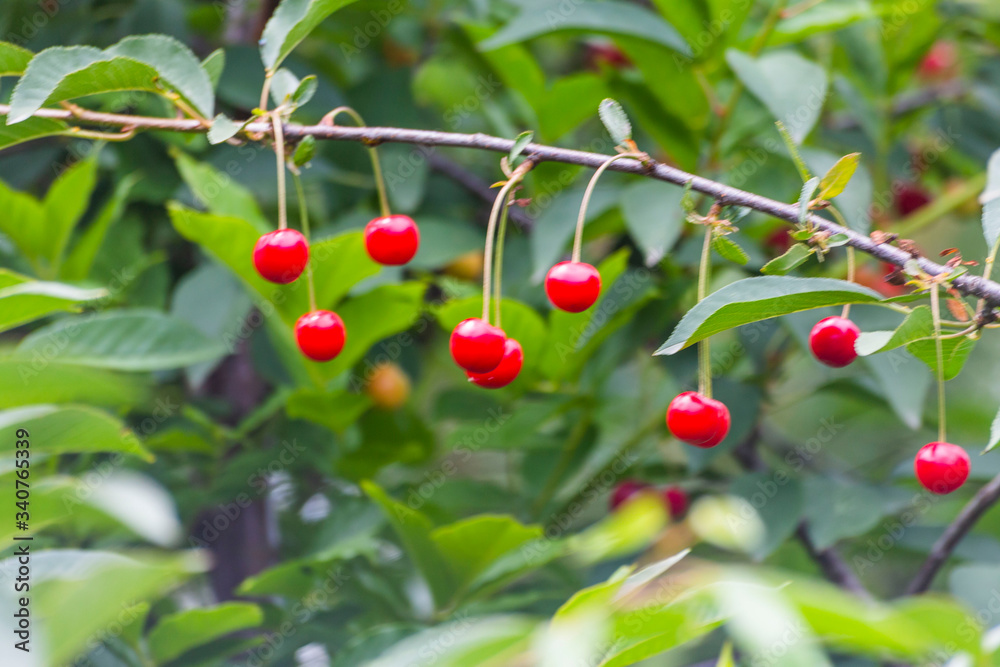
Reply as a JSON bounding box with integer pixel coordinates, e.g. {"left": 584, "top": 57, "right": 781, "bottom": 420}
{"left": 654, "top": 276, "right": 881, "bottom": 355}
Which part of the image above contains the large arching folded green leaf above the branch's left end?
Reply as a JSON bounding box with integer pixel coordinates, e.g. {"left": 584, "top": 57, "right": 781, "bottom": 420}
{"left": 7, "top": 35, "right": 215, "bottom": 124}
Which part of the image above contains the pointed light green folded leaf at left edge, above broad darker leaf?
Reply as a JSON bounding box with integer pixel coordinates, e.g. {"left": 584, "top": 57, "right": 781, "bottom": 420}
{"left": 0, "top": 269, "right": 108, "bottom": 331}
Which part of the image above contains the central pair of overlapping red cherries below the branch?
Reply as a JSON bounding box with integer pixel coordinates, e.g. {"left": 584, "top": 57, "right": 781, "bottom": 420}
{"left": 449, "top": 317, "right": 524, "bottom": 389}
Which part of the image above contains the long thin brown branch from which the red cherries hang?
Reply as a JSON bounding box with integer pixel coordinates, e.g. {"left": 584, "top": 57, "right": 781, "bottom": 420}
{"left": 0, "top": 105, "right": 1000, "bottom": 306}
